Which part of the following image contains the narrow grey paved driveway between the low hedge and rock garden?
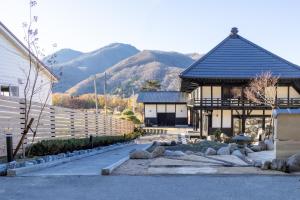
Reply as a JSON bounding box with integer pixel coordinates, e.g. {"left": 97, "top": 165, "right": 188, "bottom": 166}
{"left": 20, "top": 144, "right": 146, "bottom": 175}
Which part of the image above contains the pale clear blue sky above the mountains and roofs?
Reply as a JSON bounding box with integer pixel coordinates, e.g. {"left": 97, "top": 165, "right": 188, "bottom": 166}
{"left": 0, "top": 0, "right": 300, "bottom": 65}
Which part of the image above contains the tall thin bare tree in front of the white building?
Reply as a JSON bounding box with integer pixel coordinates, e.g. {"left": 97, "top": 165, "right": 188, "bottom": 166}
{"left": 14, "top": 0, "right": 56, "bottom": 156}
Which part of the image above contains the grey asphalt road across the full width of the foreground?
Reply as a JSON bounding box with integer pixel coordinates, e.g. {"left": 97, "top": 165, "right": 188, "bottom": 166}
{"left": 0, "top": 175, "right": 300, "bottom": 200}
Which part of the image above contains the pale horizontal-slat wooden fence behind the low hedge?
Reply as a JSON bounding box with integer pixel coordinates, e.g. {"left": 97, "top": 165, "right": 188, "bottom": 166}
{"left": 0, "top": 96, "right": 134, "bottom": 156}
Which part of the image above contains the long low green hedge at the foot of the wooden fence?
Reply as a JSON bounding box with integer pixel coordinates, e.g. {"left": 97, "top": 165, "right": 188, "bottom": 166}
{"left": 26, "top": 131, "right": 142, "bottom": 157}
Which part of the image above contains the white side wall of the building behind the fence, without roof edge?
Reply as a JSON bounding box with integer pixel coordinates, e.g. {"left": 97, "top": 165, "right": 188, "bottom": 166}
{"left": 0, "top": 31, "right": 52, "bottom": 104}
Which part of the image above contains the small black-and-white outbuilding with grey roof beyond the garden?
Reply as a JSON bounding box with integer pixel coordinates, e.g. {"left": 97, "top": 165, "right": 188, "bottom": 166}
{"left": 137, "top": 91, "right": 188, "bottom": 126}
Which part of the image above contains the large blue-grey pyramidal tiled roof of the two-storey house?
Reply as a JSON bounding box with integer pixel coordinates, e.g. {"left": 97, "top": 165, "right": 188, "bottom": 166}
{"left": 180, "top": 28, "right": 300, "bottom": 79}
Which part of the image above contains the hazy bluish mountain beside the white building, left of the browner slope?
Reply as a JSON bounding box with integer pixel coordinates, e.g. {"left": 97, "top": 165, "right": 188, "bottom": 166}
{"left": 43, "top": 43, "right": 139, "bottom": 92}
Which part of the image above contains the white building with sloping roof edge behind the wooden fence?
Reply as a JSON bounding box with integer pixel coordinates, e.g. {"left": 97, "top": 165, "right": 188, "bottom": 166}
{"left": 0, "top": 22, "right": 57, "bottom": 104}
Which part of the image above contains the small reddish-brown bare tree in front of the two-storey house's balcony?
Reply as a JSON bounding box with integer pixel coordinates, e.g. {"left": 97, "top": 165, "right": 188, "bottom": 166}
{"left": 244, "top": 71, "right": 279, "bottom": 136}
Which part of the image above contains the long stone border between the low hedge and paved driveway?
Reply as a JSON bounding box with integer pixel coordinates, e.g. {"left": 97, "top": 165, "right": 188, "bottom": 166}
{"left": 7, "top": 143, "right": 134, "bottom": 176}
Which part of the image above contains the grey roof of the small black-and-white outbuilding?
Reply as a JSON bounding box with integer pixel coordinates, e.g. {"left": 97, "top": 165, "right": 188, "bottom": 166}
{"left": 137, "top": 91, "right": 186, "bottom": 103}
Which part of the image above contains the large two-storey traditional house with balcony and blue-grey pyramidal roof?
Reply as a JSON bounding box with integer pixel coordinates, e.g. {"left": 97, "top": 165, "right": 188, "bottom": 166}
{"left": 180, "top": 28, "right": 300, "bottom": 136}
